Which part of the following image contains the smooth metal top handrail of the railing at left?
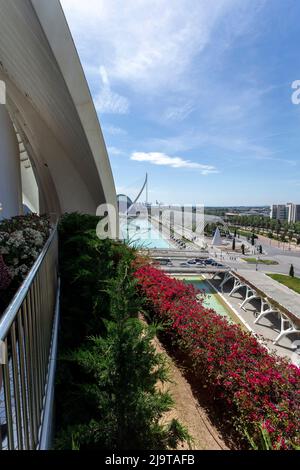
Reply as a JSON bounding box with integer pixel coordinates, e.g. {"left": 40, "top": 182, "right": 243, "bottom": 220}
{"left": 0, "top": 223, "right": 58, "bottom": 341}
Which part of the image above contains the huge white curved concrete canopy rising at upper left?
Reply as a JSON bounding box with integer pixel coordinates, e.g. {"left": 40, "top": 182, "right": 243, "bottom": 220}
{"left": 0, "top": 0, "right": 116, "bottom": 215}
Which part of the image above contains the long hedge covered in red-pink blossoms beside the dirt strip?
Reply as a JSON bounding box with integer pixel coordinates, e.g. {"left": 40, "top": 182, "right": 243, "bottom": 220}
{"left": 135, "top": 265, "right": 300, "bottom": 449}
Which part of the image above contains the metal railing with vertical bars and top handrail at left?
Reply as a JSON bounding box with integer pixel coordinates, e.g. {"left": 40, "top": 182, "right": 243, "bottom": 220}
{"left": 0, "top": 226, "right": 58, "bottom": 450}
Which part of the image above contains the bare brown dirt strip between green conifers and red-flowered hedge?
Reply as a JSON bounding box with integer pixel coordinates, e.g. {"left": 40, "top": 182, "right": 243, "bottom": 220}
{"left": 155, "top": 339, "right": 229, "bottom": 450}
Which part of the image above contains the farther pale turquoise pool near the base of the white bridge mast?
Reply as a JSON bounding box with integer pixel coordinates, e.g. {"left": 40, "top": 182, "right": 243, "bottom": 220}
{"left": 121, "top": 219, "right": 174, "bottom": 249}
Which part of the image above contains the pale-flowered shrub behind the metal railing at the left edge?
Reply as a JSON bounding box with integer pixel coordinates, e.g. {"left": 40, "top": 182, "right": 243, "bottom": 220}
{"left": 0, "top": 214, "right": 50, "bottom": 289}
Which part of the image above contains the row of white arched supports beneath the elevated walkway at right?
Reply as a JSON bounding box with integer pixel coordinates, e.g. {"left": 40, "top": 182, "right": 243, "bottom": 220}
{"left": 220, "top": 271, "right": 300, "bottom": 344}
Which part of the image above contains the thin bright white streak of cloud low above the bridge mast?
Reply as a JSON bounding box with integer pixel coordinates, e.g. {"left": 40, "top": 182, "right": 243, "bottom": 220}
{"left": 130, "top": 152, "right": 217, "bottom": 175}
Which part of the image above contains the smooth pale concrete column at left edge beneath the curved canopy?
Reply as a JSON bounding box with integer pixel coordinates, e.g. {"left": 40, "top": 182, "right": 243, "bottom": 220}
{"left": 0, "top": 104, "right": 22, "bottom": 219}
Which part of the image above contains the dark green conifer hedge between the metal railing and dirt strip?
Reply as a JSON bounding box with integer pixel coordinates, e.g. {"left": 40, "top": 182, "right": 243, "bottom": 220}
{"left": 56, "top": 214, "right": 189, "bottom": 450}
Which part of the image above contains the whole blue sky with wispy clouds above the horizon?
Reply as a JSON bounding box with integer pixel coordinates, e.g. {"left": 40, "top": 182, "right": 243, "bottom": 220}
{"left": 61, "top": 0, "right": 300, "bottom": 206}
